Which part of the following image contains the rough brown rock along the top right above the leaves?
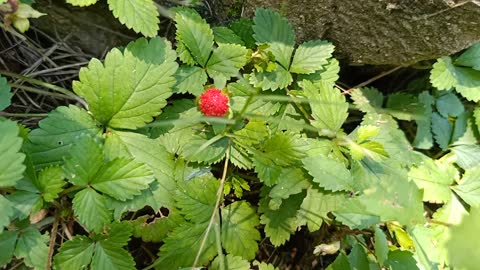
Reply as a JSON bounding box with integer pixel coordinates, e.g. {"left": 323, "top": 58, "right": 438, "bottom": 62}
{"left": 240, "top": 0, "right": 480, "bottom": 65}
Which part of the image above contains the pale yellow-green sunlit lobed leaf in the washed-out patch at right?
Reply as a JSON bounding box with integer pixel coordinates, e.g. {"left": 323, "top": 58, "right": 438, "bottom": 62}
{"left": 408, "top": 157, "right": 457, "bottom": 203}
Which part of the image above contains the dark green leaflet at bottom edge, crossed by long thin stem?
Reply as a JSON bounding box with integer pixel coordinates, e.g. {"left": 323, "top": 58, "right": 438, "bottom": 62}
{"left": 155, "top": 222, "right": 217, "bottom": 270}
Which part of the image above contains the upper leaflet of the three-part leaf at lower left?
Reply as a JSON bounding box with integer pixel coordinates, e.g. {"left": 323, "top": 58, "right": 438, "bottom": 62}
{"left": 63, "top": 136, "right": 105, "bottom": 186}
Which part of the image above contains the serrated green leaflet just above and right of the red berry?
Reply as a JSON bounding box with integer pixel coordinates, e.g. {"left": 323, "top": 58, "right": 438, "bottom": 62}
{"left": 206, "top": 43, "right": 247, "bottom": 81}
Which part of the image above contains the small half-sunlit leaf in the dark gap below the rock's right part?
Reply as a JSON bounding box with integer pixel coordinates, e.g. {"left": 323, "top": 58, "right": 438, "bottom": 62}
{"left": 351, "top": 87, "right": 383, "bottom": 113}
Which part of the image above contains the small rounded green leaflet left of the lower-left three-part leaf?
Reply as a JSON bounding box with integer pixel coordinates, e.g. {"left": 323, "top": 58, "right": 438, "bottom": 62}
{"left": 35, "top": 166, "right": 66, "bottom": 202}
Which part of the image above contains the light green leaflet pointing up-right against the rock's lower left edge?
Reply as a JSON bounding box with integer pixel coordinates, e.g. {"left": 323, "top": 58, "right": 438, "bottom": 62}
{"left": 290, "top": 40, "right": 335, "bottom": 74}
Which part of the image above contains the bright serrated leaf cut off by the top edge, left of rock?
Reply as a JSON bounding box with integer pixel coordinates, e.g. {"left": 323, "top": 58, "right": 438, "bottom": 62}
{"left": 108, "top": 0, "right": 160, "bottom": 37}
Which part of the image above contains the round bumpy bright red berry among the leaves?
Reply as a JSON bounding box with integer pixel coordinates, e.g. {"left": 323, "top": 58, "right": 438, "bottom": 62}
{"left": 198, "top": 88, "right": 228, "bottom": 116}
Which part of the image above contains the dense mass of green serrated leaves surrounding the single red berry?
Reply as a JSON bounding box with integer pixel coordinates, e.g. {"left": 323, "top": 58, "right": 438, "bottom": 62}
{"left": 0, "top": 4, "right": 480, "bottom": 270}
